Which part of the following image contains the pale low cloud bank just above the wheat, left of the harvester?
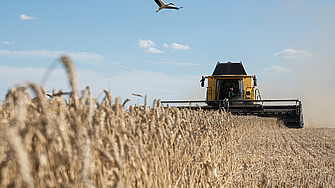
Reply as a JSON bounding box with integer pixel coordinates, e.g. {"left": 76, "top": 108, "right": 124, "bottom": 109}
{"left": 0, "top": 65, "right": 204, "bottom": 104}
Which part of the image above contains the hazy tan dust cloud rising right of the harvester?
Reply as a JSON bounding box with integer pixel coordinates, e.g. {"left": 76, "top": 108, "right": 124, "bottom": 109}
{"left": 259, "top": 3, "right": 335, "bottom": 128}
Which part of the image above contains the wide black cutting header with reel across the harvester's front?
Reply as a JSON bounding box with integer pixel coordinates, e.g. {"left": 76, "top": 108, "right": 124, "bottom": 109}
{"left": 161, "top": 99, "right": 304, "bottom": 128}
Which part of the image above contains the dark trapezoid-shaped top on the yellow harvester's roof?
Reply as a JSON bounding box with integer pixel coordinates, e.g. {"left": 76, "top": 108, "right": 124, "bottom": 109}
{"left": 212, "top": 61, "right": 247, "bottom": 76}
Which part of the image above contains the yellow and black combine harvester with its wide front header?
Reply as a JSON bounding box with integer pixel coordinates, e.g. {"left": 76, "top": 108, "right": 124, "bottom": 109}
{"left": 161, "top": 62, "right": 304, "bottom": 128}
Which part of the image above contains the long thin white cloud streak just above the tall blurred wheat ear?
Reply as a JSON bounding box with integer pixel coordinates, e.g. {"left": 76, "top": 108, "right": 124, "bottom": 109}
{"left": 0, "top": 49, "right": 104, "bottom": 64}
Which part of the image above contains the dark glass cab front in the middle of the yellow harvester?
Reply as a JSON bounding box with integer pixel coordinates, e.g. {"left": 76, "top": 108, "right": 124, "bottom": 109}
{"left": 216, "top": 79, "right": 242, "bottom": 100}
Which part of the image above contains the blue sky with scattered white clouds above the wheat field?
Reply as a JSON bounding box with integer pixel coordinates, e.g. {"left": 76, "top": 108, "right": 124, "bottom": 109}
{"left": 0, "top": 0, "right": 335, "bottom": 126}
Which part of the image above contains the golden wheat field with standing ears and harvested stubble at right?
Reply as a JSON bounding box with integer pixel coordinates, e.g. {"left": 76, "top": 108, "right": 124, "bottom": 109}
{"left": 0, "top": 57, "right": 335, "bottom": 188}
